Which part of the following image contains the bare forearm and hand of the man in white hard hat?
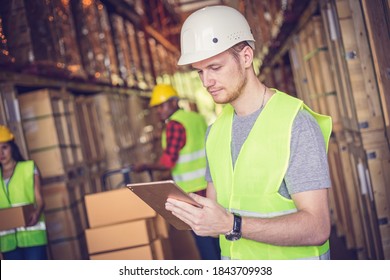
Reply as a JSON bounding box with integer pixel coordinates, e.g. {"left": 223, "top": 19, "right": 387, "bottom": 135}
{"left": 166, "top": 183, "right": 330, "bottom": 246}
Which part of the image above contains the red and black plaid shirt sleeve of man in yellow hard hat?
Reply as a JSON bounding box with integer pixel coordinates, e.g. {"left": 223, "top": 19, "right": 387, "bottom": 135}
{"left": 160, "top": 121, "right": 186, "bottom": 168}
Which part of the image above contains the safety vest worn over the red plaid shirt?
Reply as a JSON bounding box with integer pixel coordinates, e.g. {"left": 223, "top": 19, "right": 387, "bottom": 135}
{"left": 162, "top": 110, "right": 207, "bottom": 193}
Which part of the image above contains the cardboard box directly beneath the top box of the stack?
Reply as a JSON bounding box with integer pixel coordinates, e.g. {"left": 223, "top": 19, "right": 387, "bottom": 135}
{"left": 85, "top": 219, "right": 156, "bottom": 254}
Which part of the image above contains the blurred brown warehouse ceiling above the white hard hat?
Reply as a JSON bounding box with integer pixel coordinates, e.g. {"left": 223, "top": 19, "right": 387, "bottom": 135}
{"left": 101, "top": 0, "right": 319, "bottom": 69}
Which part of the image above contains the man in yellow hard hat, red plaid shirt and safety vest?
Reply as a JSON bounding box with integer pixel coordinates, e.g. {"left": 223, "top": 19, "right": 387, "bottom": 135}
{"left": 133, "top": 84, "right": 220, "bottom": 260}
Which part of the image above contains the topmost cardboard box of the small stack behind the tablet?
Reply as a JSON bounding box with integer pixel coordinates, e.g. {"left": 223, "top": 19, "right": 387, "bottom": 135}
{"left": 85, "top": 188, "right": 156, "bottom": 228}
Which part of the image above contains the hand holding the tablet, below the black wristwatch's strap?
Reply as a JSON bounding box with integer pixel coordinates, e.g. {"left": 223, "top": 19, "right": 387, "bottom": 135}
{"left": 165, "top": 193, "right": 233, "bottom": 236}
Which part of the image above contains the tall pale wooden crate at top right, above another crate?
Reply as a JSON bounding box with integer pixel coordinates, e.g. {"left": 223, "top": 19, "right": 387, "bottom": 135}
{"left": 333, "top": 0, "right": 384, "bottom": 131}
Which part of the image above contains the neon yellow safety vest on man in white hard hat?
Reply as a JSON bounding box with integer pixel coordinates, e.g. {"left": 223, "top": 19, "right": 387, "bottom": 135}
{"left": 206, "top": 91, "right": 332, "bottom": 260}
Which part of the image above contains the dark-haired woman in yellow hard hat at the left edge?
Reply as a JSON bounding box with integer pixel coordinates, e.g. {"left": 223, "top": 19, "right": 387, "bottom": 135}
{"left": 0, "top": 125, "right": 47, "bottom": 260}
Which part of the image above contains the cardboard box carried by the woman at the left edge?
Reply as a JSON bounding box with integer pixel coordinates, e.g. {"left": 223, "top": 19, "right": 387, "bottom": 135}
{"left": 0, "top": 204, "right": 34, "bottom": 230}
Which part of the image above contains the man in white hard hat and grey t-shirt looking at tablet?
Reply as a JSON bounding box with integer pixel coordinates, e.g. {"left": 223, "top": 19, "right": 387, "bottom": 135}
{"left": 166, "top": 6, "right": 332, "bottom": 260}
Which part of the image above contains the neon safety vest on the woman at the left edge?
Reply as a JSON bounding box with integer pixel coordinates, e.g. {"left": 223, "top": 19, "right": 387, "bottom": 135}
{"left": 0, "top": 160, "right": 47, "bottom": 252}
